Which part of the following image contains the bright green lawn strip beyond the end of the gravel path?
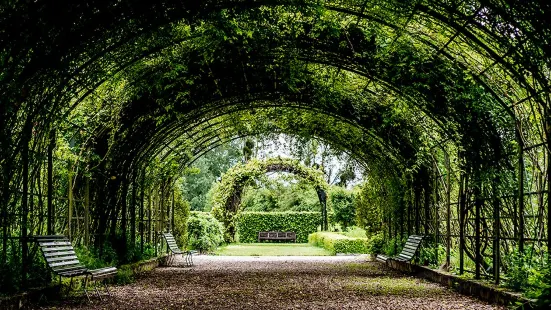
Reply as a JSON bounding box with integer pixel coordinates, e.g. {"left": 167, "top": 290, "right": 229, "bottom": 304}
{"left": 215, "top": 243, "right": 331, "bottom": 256}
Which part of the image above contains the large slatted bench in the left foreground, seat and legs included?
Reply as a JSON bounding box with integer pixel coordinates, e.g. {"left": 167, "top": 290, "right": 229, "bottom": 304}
{"left": 32, "top": 235, "right": 117, "bottom": 301}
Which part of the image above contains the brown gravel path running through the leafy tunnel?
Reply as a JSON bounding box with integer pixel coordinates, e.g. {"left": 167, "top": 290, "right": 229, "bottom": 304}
{"left": 33, "top": 256, "right": 505, "bottom": 310}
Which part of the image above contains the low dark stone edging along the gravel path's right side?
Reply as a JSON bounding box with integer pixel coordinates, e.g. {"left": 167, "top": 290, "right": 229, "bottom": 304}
{"left": 386, "top": 260, "right": 534, "bottom": 309}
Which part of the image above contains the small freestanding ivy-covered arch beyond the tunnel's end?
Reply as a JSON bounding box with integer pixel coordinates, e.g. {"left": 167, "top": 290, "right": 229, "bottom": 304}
{"left": 211, "top": 157, "right": 329, "bottom": 242}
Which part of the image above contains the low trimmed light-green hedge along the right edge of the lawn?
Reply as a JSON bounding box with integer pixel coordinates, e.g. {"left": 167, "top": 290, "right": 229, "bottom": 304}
{"left": 308, "top": 232, "right": 369, "bottom": 255}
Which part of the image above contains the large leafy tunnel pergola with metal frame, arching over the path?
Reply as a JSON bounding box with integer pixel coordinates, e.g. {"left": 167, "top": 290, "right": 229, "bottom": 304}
{"left": 0, "top": 0, "right": 551, "bottom": 290}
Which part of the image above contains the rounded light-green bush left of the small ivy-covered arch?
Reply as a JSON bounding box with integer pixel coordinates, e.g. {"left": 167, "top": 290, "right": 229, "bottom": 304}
{"left": 187, "top": 211, "right": 224, "bottom": 253}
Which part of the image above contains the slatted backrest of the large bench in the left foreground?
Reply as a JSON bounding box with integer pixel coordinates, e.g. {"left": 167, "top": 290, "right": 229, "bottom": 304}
{"left": 33, "top": 235, "right": 87, "bottom": 275}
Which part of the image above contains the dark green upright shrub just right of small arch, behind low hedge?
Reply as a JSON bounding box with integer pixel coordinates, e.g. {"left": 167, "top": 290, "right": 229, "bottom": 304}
{"left": 328, "top": 186, "right": 356, "bottom": 229}
